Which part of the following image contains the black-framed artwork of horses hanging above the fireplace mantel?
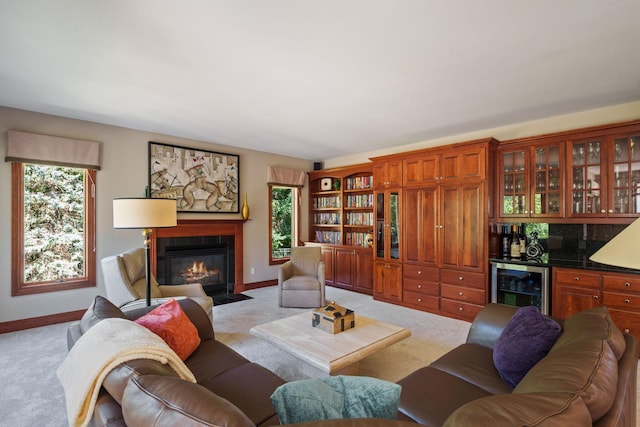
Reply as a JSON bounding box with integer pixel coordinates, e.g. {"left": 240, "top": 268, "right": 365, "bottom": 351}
{"left": 148, "top": 141, "right": 240, "bottom": 213}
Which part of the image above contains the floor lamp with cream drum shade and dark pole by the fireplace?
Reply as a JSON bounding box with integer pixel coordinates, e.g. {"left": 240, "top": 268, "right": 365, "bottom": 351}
{"left": 113, "top": 197, "right": 178, "bottom": 307}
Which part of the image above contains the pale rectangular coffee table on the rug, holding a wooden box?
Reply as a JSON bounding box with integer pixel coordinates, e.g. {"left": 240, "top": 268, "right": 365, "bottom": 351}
{"left": 251, "top": 312, "right": 411, "bottom": 376}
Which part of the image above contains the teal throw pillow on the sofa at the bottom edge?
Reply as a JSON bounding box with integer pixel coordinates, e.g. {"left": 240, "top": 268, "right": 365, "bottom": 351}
{"left": 271, "top": 375, "right": 402, "bottom": 424}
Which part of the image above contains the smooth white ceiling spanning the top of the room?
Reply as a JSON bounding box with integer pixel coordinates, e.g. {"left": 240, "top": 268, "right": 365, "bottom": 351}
{"left": 0, "top": 0, "right": 640, "bottom": 160}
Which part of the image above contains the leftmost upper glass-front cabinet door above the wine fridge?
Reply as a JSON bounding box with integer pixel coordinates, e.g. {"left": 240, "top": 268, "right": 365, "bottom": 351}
{"left": 500, "top": 149, "right": 529, "bottom": 217}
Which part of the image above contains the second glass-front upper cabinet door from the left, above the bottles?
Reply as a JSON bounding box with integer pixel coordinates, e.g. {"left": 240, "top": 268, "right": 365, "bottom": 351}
{"left": 529, "top": 145, "right": 564, "bottom": 217}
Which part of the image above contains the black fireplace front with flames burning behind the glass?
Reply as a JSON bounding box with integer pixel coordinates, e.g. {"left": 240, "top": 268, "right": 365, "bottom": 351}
{"left": 165, "top": 245, "right": 228, "bottom": 292}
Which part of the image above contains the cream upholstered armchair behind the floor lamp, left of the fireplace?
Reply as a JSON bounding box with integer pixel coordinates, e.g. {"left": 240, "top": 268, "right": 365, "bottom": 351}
{"left": 100, "top": 248, "right": 213, "bottom": 319}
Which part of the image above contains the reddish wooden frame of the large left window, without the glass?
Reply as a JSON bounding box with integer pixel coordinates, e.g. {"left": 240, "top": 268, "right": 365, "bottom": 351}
{"left": 11, "top": 162, "right": 96, "bottom": 296}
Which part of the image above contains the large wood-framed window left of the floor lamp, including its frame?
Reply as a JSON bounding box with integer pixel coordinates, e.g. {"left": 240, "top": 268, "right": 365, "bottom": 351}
{"left": 11, "top": 162, "right": 96, "bottom": 296}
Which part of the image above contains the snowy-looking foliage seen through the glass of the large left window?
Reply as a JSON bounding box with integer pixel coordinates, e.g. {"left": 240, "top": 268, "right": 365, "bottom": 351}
{"left": 24, "top": 164, "right": 85, "bottom": 283}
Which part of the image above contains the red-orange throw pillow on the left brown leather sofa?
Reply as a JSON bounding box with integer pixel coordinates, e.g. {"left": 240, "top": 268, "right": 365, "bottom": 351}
{"left": 135, "top": 298, "right": 200, "bottom": 361}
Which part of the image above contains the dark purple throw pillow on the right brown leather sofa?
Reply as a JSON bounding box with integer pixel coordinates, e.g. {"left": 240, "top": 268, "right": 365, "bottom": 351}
{"left": 493, "top": 306, "right": 562, "bottom": 387}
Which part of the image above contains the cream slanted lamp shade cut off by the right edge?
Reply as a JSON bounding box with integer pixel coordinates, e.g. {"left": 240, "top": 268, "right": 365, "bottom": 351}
{"left": 589, "top": 218, "right": 640, "bottom": 270}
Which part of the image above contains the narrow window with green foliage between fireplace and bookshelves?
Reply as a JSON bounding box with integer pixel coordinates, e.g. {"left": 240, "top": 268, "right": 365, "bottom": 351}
{"left": 269, "top": 185, "right": 300, "bottom": 264}
